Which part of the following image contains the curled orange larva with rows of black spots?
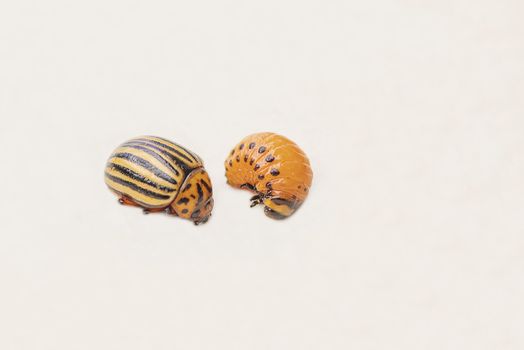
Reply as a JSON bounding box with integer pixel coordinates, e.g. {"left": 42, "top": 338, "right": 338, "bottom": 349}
{"left": 225, "top": 132, "right": 313, "bottom": 219}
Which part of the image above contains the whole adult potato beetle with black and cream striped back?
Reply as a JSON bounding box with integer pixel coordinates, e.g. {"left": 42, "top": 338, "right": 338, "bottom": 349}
{"left": 105, "top": 136, "right": 213, "bottom": 225}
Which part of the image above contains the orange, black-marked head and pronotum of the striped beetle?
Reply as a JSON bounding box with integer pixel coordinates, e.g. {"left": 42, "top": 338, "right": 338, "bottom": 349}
{"left": 171, "top": 168, "right": 213, "bottom": 225}
